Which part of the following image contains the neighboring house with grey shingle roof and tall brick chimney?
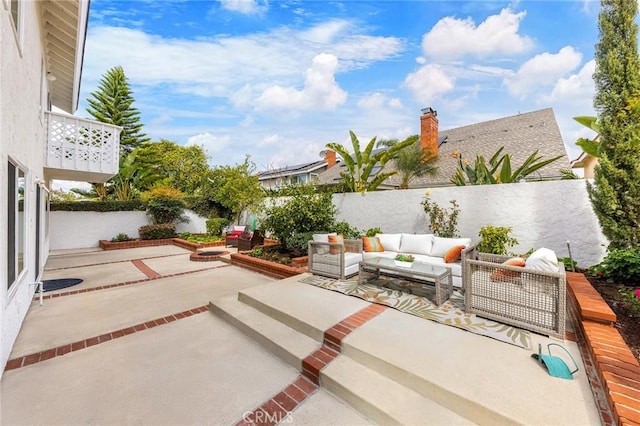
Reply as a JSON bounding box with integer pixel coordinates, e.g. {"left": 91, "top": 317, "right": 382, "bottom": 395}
{"left": 318, "top": 108, "right": 570, "bottom": 189}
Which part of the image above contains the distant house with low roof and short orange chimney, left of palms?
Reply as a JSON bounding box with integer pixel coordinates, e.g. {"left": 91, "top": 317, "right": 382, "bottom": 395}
{"left": 258, "top": 150, "right": 336, "bottom": 189}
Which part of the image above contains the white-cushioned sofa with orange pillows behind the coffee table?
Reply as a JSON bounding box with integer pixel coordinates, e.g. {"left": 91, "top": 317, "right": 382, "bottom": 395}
{"left": 362, "top": 234, "right": 473, "bottom": 287}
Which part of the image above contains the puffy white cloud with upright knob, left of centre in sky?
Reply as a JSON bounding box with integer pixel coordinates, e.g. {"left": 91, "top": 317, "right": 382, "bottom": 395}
{"left": 255, "top": 53, "right": 347, "bottom": 110}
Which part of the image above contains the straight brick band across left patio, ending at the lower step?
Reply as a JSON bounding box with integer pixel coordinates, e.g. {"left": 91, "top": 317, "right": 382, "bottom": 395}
{"left": 4, "top": 305, "right": 209, "bottom": 371}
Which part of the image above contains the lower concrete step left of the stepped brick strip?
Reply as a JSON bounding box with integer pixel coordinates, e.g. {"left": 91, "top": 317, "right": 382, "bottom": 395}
{"left": 209, "top": 296, "right": 320, "bottom": 371}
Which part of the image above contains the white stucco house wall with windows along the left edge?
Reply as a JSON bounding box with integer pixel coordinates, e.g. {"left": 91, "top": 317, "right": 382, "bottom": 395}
{"left": 0, "top": 1, "right": 46, "bottom": 376}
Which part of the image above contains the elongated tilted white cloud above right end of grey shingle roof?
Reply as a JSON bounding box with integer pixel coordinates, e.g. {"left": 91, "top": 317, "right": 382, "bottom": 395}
{"left": 504, "top": 46, "right": 582, "bottom": 99}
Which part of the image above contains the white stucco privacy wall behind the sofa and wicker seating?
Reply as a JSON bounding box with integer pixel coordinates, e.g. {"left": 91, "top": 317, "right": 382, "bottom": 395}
{"left": 333, "top": 179, "right": 607, "bottom": 267}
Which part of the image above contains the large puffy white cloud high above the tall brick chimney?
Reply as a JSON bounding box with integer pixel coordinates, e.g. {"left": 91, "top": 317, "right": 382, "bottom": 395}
{"left": 422, "top": 8, "right": 533, "bottom": 60}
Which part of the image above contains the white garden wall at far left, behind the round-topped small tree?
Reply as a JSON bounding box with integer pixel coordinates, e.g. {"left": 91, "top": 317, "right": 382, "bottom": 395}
{"left": 49, "top": 210, "right": 207, "bottom": 250}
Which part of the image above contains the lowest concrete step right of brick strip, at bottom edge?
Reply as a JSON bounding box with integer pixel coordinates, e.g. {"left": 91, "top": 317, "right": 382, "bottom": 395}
{"left": 320, "top": 355, "right": 474, "bottom": 425}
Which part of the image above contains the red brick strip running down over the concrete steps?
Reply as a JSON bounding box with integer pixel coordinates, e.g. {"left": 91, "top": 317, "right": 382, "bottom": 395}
{"left": 236, "top": 303, "right": 387, "bottom": 426}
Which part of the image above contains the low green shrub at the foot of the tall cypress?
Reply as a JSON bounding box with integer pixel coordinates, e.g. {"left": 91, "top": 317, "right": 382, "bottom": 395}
{"left": 589, "top": 246, "right": 640, "bottom": 284}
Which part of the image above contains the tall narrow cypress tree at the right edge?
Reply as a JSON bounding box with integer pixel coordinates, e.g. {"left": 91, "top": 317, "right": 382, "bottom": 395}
{"left": 587, "top": 0, "right": 640, "bottom": 248}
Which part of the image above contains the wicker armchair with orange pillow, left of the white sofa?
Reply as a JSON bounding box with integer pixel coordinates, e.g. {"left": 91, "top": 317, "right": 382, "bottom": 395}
{"left": 308, "top": 240, "right": 362, "bottom": 280}
